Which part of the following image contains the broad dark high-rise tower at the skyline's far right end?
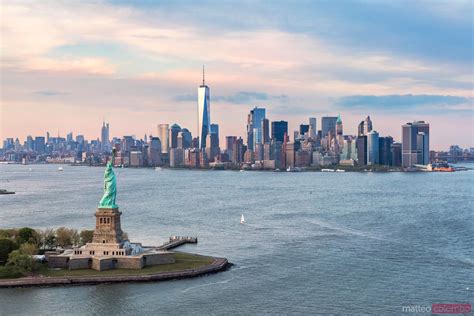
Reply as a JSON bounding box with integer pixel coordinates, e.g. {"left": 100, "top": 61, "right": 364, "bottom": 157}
{"left": 402, "top": 121, "right": 430, "bottom": 167}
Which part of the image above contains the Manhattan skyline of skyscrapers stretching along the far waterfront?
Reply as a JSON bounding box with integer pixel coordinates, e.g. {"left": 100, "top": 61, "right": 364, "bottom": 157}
{"left": 6, "top": 68, "right": 474, "bottom": 170}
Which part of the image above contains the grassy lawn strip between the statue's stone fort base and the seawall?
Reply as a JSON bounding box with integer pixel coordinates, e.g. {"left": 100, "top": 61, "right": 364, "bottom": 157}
{"left": 35, "top": 252, "right": 213, "bottom": 277}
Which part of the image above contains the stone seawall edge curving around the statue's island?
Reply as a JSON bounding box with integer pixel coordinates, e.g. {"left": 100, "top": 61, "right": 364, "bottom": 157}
{"left": 0, "top": 257, "right": 232, "bottom": 288}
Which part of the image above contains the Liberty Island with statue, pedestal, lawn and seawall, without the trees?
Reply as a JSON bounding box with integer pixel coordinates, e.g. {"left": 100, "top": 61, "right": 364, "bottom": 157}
{"left": 0, "top": 151, "right": 229, "bottom": 287}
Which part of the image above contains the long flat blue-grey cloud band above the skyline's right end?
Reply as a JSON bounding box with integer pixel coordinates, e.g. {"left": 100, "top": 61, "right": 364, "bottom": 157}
{"left": 334, "top": 94, "right": 473, "bottom": 111}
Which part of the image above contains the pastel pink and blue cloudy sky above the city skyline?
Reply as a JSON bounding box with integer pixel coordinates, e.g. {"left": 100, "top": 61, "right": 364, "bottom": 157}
{"left": 0, "top": 0, "right": 474, "bottom": 150}
